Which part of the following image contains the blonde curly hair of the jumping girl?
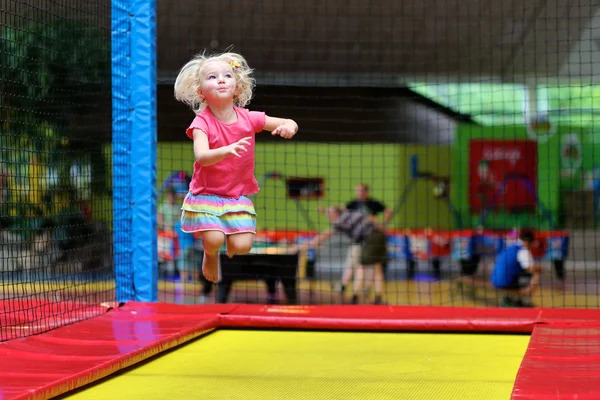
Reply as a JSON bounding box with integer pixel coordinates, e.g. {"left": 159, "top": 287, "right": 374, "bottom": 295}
{"left": 175, "top": 52, "right": 255, "bottom": 114}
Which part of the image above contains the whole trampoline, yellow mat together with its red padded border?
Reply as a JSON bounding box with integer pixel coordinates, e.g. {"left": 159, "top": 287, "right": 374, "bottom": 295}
{"left": 0, "top": 302, "right": 600, "bottom": 400}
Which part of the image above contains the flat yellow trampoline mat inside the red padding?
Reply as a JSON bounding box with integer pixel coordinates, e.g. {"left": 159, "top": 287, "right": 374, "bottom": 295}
{"left": 64, "top": 330, "right": 529, "bottom": 400}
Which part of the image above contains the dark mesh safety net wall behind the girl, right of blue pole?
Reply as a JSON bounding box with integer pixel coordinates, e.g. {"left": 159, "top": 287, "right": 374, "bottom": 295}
{"left": 157, "top": 1, "right": 600, "bottom": 307}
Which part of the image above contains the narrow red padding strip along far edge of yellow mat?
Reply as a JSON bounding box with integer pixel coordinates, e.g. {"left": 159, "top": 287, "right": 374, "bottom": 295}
{"left": 219, "top": 304, "right": 539, "bottom": 333}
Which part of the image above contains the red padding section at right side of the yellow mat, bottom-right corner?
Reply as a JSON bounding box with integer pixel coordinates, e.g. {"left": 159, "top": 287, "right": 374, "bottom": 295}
{"left": 512, "top": 323, "right": 600, "bottom": 400}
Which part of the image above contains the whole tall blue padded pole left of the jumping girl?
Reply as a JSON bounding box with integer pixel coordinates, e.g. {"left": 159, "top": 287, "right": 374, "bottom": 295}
{"left": 112, "top": 0, "right": 158, "bottom": 302}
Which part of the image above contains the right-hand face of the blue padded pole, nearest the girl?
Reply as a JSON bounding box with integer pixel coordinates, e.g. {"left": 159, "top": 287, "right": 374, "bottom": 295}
{"left": 130, "top": 0, "right": 158, "bottom": 301}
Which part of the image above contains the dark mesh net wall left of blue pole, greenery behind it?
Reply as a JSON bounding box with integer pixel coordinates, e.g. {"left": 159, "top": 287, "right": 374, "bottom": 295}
{"left": 0, "top": 0, "right": 118, "bottom": 340}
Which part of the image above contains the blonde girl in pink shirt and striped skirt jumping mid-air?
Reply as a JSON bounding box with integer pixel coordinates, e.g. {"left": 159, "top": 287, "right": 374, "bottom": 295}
{"left": 175, "top": 52, "right": 298, "bottom": 282}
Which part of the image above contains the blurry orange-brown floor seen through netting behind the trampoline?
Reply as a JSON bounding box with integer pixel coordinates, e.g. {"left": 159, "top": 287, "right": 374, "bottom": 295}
{"left": 159, "top": 273, "right": 600, "bottom": 308}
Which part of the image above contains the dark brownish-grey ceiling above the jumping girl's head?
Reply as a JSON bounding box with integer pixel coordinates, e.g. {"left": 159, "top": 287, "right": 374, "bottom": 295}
{"left": 157, "top": 0, "right": 600, "bottom": 86}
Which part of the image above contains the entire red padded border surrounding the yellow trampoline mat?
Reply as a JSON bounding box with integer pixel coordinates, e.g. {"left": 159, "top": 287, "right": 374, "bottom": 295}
{"left": 0, "top": 303, "right": 600, "bottom": 400}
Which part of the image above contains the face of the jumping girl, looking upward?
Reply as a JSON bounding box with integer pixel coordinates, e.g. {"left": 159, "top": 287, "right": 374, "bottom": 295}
{"left": 198, "top": 61, "right": 237, "bottom": 104}
